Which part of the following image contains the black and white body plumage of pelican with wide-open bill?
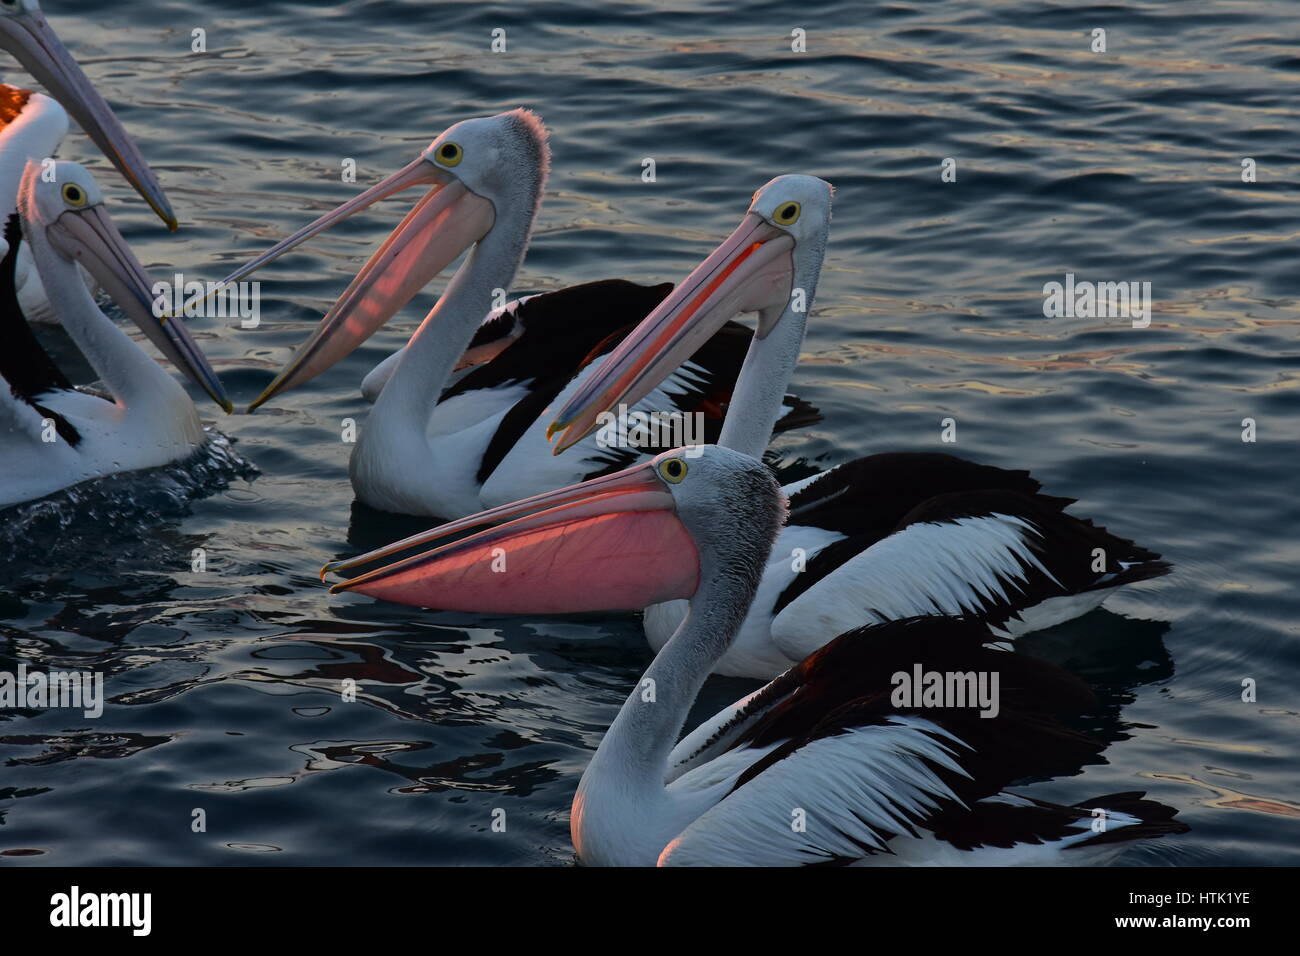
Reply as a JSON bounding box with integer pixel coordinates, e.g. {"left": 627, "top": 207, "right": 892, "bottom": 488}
{"left": 348, "top": 280, "right": 800, "bottom": 515}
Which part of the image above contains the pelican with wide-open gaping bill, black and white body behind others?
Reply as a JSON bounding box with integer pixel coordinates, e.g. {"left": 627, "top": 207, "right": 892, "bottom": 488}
{"left": 206, "top": 109, "right": 807, "bottom": 518}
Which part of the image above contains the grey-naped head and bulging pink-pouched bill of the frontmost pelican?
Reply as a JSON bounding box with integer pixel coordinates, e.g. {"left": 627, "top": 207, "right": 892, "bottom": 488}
{"left": 321, "top": 445, "right": 785, "bottom": 616}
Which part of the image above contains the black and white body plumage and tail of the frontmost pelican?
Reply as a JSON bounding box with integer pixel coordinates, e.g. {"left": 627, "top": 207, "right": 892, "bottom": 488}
{"left": 659, "top": 617, "right": 1187, "bottom": 866}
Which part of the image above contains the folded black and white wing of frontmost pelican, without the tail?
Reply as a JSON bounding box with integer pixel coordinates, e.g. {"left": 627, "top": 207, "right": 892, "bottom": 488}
{"left": 659, "top": 618, "right": 1100, "bottom": 866}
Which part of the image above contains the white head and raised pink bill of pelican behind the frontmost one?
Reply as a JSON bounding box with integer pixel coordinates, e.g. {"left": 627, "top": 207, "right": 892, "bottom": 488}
{"left": 547, "top": 176, "right": 832, "bottom": 454}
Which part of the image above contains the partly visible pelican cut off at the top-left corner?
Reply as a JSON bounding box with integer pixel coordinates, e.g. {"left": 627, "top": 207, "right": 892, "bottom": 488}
{"left": 0, "top": 0, "right": 177, "bottom": 321}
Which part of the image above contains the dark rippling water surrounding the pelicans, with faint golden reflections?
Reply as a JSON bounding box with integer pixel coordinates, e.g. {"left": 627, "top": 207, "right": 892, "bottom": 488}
{"left": 0, "top": 0, "right": 1300, "bottom": 865}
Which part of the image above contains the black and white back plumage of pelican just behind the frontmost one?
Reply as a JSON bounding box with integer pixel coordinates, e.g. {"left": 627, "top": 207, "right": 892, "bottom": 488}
{"left": 772, "top": 453, "right": 1169, "bottom": 647}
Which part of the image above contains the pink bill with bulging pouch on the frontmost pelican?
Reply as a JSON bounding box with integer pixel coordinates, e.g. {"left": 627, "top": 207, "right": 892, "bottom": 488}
{"left": 321, "top": 464, "right": 699, "bottom": 614}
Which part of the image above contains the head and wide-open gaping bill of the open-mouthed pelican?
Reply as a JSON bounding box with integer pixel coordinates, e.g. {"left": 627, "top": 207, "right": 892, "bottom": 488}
{"left": 217, "top": 109, "right": 550, "bottom": 410}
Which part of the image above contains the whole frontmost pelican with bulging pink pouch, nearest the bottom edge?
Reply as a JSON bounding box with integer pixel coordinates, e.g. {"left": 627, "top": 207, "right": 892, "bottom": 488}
{"left": 322, "top": 446, "right": 1187, "bottom": 866}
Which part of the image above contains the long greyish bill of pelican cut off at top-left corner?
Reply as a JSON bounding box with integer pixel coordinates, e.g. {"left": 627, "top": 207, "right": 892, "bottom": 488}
{"left": 0, "top": 0, "right": 178, "bottom": 232}
